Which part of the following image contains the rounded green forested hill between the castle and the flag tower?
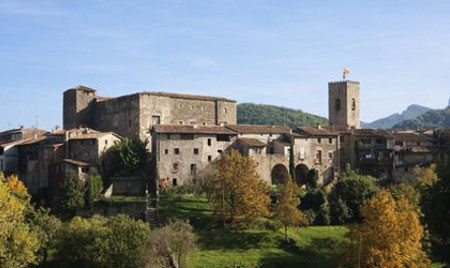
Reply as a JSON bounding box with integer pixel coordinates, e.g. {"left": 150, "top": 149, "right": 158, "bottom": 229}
{"left": 237, "top": 103, "right": 328, "bottom": 129}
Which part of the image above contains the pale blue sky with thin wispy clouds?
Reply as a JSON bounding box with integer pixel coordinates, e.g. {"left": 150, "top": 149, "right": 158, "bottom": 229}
{"left": 0, "top": 0, "right": 450, "bottom": 130}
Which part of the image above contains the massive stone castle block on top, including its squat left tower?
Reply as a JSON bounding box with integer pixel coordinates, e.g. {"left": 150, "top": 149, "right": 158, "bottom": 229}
{"left": 63, "top": 86, "right": 236, "bottom": 147}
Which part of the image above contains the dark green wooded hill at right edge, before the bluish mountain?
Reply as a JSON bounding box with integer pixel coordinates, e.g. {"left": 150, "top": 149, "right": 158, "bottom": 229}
{"left": 393, "top": 107, "right": 450, "bottom": 130}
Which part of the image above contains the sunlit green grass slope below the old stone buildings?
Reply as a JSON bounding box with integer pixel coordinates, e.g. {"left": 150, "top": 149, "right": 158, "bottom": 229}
{"left": 160, "top": 194, "right": 347, "bottom": 268}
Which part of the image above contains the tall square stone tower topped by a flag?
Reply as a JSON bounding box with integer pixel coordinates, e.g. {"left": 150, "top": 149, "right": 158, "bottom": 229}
{"left": 328, "top": 80, "right": 361, "bottom": 130}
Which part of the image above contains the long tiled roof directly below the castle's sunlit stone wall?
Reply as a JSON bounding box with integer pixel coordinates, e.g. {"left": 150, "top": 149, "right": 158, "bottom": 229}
{"left": 153, "top": 125, "right": 236, "bottom": 134}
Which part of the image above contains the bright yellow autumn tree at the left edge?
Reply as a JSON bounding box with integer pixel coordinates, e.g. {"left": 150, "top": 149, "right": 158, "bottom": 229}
{"left": 0, "top": 173, "right": 40, "bottom": 268}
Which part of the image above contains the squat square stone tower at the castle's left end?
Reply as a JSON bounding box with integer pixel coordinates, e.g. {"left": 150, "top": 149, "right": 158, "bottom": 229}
{"left": 63, "top": 86, "right": 96, "bottom": 130}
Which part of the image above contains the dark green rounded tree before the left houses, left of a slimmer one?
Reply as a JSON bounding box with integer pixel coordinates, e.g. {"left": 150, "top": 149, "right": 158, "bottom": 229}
{"left": 59, "top": 173, "right": 86, "bottom": 216}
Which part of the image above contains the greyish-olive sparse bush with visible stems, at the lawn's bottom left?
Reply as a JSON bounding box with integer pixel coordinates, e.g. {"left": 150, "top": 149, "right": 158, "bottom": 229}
{"left": 140, "top": 220, "right": 196, "bottom": 268}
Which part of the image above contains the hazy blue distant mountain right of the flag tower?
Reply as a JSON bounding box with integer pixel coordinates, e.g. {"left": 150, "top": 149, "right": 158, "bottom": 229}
{"left": 362, "top": 104, "right": 431, "bottom": 129}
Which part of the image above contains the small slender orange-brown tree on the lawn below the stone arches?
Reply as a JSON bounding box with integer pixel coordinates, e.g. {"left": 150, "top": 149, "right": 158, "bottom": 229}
{"left": 274, "top": 176, "right": 307, "bottom": 243}
